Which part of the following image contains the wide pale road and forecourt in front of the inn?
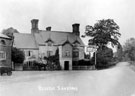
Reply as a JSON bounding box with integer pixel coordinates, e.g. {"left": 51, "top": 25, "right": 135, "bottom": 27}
{"left": 0, "top": 63, "right": 135, "bottom": 96}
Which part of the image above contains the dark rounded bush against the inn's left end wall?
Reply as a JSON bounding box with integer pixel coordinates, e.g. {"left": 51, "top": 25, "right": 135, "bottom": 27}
{"left": 11, "top": 47, "right": 25, "bottom": 63}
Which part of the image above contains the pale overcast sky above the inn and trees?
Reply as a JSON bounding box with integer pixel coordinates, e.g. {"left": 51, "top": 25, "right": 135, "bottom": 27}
{"left": 0, "top": 0, "right": 135, "bottom": 44}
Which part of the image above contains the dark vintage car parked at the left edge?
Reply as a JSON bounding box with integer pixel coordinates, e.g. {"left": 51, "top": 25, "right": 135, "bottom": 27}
{"left": 0, "top": 66, "right": 12, "bottom": 76}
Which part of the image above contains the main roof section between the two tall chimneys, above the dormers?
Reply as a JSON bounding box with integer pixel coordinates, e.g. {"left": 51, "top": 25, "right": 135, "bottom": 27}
{"left": 34, "top": 30, "right": 84, "bottom": 46}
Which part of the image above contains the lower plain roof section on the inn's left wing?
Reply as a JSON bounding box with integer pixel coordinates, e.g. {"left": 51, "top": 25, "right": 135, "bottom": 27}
{"left": 13, "top": 33, "right": 38, "bottom": 49}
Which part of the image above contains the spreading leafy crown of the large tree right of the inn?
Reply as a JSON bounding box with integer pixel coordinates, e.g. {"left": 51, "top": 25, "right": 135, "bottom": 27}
{"left": 84, "top": 19, "right": 121, "bottom": 46}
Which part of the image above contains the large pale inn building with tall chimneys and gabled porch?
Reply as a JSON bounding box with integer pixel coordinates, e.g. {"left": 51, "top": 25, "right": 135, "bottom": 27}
{"left": 13, "top": 19, "right": 85, "bottom": 70}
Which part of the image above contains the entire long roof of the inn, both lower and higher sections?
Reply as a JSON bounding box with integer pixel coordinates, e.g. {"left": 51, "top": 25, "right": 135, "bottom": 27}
{"left": 14, "top": 30, "right": 84, "bottom": 49}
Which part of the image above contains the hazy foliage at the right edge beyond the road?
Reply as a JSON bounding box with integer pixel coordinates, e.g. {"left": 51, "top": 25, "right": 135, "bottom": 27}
{"left": 123, "top": 38, "right": 135, "bottom": 61}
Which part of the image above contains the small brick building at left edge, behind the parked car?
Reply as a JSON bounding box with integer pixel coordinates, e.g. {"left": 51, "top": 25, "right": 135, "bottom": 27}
{"left": 0, "top": 34, "right": 12, "bottom": 67}
